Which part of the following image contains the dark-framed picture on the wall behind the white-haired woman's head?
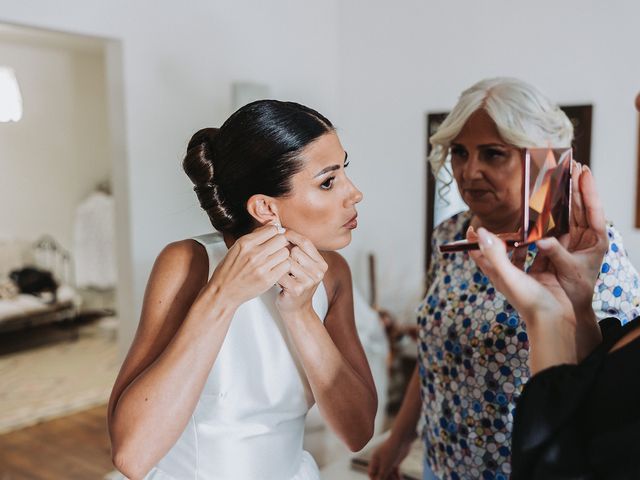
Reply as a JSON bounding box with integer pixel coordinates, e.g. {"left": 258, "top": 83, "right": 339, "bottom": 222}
{"left": 424, "top": 104, "right": 596, "bottom": 278}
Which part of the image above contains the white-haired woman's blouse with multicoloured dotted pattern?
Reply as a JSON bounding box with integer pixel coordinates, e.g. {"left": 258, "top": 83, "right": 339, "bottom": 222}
{"left": 418, "top": 211, "right": 640, "bottom": 480}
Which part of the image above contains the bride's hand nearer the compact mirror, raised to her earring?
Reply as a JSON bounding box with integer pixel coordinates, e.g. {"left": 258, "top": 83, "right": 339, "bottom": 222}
{"left": 276, "top": 229, "right": 328, "bottom": 315}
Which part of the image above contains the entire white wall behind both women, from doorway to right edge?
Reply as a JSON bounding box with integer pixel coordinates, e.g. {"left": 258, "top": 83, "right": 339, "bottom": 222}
{"left": 0, "top": 0, "right": 640, "bottom": 344}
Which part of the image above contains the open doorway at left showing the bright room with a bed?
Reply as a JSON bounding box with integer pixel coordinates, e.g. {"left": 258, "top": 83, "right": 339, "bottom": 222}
{"left": 0, "top": 24, "right": 129, "bottom": 433}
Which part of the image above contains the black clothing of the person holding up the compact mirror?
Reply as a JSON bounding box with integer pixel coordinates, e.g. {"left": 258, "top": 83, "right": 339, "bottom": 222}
{"left": 511, "top": 318, "right": 640, "bottom": 480}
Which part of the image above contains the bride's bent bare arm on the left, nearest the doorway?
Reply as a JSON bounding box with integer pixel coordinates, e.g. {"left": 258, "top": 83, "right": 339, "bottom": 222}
{"left": 108, "top": 241, "right": 234, "bottom": 479}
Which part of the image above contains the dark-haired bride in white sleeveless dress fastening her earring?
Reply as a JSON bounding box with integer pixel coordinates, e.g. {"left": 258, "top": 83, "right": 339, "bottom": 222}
{"left": 108, "top": 100, "right": 377, "bottom": 480}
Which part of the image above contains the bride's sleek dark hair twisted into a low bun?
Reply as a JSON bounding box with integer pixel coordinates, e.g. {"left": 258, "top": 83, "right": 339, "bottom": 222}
{"left": 182, "top": 100, "right": 334, "bottom": 236}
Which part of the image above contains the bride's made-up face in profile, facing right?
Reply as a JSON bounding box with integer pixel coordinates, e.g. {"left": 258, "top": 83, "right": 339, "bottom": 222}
{"left": 277, "top": 132, "right": 362, "bottom": 250}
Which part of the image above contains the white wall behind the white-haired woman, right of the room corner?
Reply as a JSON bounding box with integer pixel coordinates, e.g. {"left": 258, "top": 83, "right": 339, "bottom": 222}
{"left": 337, "top": 0, "right": 640, "bottom": 321}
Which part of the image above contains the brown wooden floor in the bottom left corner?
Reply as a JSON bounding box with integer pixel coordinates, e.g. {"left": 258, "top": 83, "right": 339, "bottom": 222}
{"left": 0, "top": 406, "right": 113, "bottom": 480}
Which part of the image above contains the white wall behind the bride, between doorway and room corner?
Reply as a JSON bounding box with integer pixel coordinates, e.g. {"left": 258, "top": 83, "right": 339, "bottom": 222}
{"left": 0, "top": 0, "right": 338, "bottom": 348}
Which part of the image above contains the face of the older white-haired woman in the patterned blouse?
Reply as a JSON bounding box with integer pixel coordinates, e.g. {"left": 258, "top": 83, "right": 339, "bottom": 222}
{"left": 451, "top": 109, "right": 522, "bottom": 223}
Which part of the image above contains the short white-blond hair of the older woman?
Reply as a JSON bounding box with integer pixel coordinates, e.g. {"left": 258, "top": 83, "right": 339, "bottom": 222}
{"left": 429, "top": 77, "right": 573, "bottom": 178}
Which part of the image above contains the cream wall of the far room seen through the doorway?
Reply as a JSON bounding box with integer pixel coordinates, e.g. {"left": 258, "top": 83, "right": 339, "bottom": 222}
{"left": 0, "top": 36, "right": 111, "bottom": 249}
